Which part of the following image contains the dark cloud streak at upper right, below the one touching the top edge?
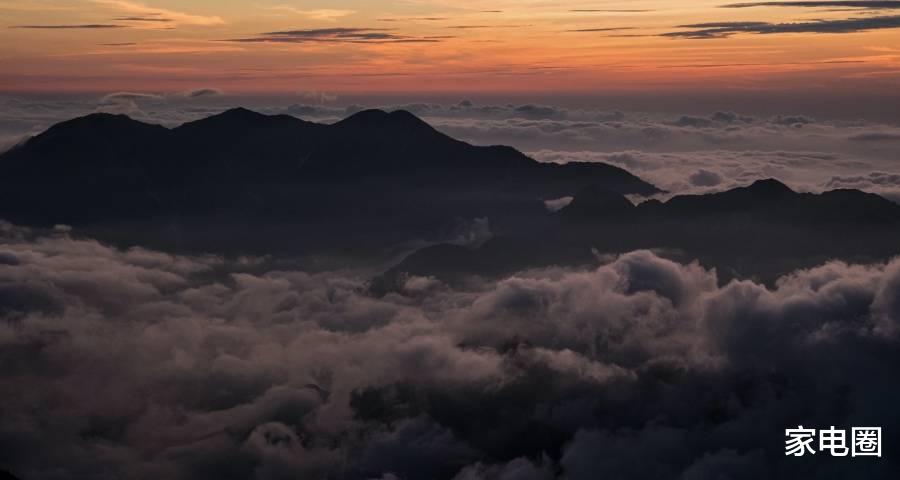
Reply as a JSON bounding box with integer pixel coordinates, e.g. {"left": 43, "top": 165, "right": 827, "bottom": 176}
{"left": 662, "top": 15, "right": 900, "bottom": 39}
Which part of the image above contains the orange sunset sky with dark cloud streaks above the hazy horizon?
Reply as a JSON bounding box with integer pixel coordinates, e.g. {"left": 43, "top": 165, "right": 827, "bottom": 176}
{"left": 0, "top": 0, "right": 900, "bottom": 93}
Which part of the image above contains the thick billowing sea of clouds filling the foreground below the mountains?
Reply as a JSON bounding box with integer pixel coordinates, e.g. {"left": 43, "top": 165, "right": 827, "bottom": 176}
{"left": 0, "top": 228, "right": 900, "bottom": 480}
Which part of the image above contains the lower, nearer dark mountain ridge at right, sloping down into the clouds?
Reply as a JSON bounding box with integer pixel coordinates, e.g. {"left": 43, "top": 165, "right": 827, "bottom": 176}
{"left": 374, "top": 179, "right": 900, "bottom": 292}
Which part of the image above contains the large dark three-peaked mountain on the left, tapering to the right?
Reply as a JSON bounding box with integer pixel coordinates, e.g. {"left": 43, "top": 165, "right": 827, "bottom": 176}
{"left": 0, "top": 108, "right": 659, "bottom": 253}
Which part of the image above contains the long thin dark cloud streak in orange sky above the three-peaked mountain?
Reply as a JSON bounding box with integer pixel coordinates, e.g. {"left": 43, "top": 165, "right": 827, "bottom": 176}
{"left": 228, "top": 27, "right": 439, "bottom": 43}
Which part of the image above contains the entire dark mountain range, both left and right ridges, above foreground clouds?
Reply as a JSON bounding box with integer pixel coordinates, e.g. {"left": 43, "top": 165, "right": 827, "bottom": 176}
{"left": 7, "top": 108, "right": 900, "bottom": 282}
